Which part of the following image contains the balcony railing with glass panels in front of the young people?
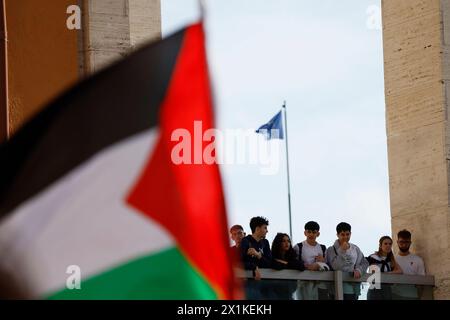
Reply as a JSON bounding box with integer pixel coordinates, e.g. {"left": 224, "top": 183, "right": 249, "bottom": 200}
{"left": 236, "top": 269, "right": 435, "bottom": 300}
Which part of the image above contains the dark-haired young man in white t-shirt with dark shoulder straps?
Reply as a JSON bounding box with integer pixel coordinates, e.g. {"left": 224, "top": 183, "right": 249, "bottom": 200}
{"left": 294, "top": 221, "right": 330, "bottom": 300}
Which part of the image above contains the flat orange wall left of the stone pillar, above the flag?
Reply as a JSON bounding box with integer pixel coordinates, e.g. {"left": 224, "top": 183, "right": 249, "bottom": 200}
{"left": 6, "top": 0, "right": 78, "bottom": 134}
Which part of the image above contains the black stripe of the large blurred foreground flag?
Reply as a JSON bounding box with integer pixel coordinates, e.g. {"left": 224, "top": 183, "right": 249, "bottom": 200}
{"left": 0, "top": 30, "right": 185, "bottom": 218}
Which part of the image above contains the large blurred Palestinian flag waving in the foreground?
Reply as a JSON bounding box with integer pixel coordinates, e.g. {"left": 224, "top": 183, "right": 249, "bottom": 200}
{"left": 0, "top": 24, "right": 234, "bottom": 299}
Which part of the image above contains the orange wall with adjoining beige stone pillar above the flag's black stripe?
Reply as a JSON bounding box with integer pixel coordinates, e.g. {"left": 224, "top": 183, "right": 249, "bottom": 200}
{"left": 1, "top": 0, "right": 161, "bottom": 135}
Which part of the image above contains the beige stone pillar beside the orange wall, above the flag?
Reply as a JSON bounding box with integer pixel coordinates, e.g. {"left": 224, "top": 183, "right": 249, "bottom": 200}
{"left": 79, "top": 0, "right": 161, "bottom": 74}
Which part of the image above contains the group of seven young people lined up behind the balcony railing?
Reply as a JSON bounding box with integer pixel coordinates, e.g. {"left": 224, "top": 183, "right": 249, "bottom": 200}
{"left": 230, "top": 217, "right": 425, "bottom": 300}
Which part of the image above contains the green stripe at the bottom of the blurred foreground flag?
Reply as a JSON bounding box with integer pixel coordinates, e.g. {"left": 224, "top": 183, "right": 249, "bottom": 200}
{"left": 47, "top": 248, "right": 217, "bottom": 299}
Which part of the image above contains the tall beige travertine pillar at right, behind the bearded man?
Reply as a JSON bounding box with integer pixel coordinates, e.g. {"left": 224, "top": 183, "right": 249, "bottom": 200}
{"left": 382, "top": 0, "right": 450, "bottom": 299}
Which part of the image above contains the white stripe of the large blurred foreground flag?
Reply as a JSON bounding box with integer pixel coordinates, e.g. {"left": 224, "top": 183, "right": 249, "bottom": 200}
{"left": 0, "top": 129, "right": 174, "bottom": 295}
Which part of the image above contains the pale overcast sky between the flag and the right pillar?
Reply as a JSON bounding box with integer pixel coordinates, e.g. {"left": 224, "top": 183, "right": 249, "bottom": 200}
{"left": 161, "top": 0, "right": 391, "bottom": 255}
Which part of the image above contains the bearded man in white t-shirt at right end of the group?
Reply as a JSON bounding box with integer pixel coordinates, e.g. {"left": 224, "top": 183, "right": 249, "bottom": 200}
{"left": 392, "top": 230, "right": 425, "bottom": 300}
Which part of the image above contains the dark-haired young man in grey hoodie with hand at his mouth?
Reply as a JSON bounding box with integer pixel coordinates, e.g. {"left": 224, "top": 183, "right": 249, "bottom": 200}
{"left": 326, "top": 222, "right": 369, "bottom": 300}
